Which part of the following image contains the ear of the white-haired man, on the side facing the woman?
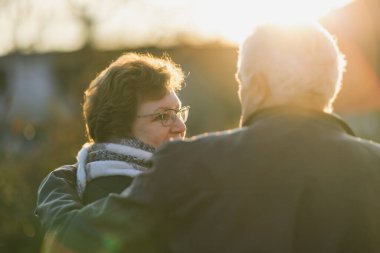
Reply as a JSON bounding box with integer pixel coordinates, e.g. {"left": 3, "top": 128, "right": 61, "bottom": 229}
{"left": 239, "top": 73, "right": 270, "bottom": 120}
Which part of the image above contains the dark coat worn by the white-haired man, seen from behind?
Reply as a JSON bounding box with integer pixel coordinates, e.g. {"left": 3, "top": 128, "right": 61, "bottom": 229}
{"left": 35, "top": 108, "right": 380, "bottom": 253}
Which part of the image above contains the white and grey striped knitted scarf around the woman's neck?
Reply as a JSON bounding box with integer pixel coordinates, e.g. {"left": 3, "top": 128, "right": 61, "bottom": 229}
{"left": 77, "top": 138, "right": 154, "bottom": 198}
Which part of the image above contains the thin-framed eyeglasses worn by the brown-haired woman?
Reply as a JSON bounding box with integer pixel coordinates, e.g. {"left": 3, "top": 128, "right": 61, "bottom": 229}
{"left": 137, "top": 106, "right": 190, "bottom": 127}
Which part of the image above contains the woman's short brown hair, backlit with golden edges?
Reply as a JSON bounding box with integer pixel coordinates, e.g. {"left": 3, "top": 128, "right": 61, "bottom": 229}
{"left": 83, "top": 53, "right": 184, "bottom": 142}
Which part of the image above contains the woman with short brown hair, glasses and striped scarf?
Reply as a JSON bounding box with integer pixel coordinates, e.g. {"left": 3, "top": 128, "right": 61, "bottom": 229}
{"left": 36, "top": 53, "right": 189, "bottom": 217}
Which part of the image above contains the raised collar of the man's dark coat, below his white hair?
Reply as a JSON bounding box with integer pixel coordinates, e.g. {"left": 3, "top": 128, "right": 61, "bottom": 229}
{"left": 242, "top": 106, "right": 356, "bottom": 136}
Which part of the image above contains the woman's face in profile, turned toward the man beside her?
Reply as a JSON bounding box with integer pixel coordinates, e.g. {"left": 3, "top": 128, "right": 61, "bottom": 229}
{"left": 132, "top": 91, "right": 186, "bottom": 148}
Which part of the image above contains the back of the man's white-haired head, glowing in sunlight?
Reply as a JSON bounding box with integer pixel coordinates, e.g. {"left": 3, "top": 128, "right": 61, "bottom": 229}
{"left": 237, "top": 24, "right": 345, "bottom": 116}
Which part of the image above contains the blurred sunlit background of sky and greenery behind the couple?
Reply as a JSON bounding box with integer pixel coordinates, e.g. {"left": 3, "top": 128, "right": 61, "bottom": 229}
{"left": 0, "top": 0, "right": 380, "bottom": 253}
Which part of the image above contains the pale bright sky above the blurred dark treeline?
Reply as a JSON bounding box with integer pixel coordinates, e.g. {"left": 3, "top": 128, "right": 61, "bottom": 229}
{"left": 0, "top": 0, "right": 352, "bottom": 56}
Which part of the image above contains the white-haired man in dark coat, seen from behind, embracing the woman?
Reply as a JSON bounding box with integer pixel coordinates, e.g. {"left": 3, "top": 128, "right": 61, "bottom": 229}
{"left": 37, "top": 22, "right": 380, "bottom": 253}
